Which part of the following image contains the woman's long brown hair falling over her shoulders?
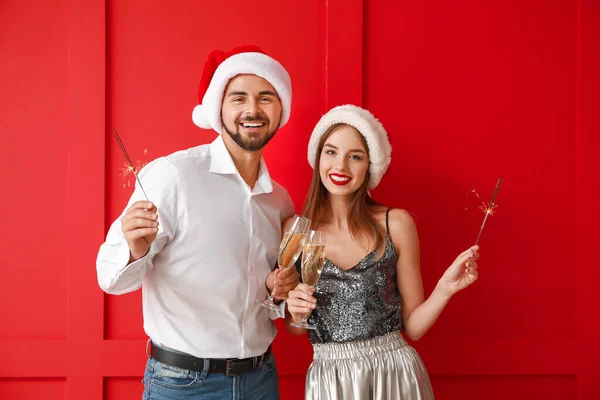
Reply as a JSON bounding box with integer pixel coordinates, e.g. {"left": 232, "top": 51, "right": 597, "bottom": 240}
{"left": 302, "top": 124, "right": 386, "bottom": 251}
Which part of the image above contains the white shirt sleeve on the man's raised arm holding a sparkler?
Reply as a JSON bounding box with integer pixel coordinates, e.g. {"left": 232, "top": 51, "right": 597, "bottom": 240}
{"left": 96, "top": 158, "right": 180, "bottom": 294}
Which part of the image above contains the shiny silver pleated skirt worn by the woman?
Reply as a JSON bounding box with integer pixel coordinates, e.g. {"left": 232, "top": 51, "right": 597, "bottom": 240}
{"left": 306, "top": 332, "right": 433, "bottom": 400}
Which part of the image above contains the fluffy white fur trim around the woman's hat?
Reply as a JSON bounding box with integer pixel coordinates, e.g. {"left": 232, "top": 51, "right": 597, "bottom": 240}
{"left": 308, "top": 104, "right": 392, "bottom": 190}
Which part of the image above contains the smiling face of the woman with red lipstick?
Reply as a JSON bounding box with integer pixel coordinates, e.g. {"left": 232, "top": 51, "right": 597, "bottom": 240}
{"left": 319, "top": 125, "right": 369, "bottom": 196}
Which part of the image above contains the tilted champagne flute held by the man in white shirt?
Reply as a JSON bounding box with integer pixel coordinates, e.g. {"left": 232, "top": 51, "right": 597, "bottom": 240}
{"left": 257, "top": 215, "right": 310, "bottom": 310}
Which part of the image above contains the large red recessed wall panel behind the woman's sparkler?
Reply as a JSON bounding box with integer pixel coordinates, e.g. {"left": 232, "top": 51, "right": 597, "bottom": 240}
{"left": 365, "top": 0, "right": 577, "bottom": 342}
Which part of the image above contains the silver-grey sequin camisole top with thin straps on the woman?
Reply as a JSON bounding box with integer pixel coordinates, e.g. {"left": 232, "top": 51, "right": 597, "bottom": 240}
{"left": 297, "top": 209, "right": 404, "bottom": 344}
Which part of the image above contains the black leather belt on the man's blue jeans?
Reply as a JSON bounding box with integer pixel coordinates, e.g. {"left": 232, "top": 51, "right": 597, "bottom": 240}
{"left": 150, "top": 343, "right": 271, "bottom": 376}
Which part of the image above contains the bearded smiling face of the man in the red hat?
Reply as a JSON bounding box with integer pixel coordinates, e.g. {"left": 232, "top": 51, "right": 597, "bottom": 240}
{"left": 221, "top": 74, "right": 282, "bottom": 151}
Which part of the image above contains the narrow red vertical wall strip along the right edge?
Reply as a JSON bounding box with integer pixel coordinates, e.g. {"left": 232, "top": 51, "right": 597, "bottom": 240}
{"left": 576, "top": 0, "right": 600, "bottom": 400}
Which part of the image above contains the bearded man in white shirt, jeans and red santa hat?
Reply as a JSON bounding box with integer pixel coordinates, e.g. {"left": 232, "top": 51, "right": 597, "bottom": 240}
{"left": 97, "top": 46, "right": 298, "bottom": 399}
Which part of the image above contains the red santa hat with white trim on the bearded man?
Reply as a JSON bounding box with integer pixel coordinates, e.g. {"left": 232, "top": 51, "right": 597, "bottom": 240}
{"left": 192, "top": 45, "right": 292, "bottom": 134}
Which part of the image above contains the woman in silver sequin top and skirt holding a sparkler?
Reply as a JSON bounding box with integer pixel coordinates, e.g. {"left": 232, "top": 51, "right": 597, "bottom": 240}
{"left": 287, "top": 105, "right": 479, "bottom": 400}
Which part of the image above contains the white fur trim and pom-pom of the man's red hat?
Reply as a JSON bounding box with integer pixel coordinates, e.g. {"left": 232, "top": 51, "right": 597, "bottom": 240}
{"left": 192, "top": 52, "right": 292, "bottom": 134}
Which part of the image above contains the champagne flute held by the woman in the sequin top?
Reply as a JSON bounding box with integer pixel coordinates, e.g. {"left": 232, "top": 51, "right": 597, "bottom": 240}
{"left": 290, "top": 231, "right": 325, "bottom": 329}
